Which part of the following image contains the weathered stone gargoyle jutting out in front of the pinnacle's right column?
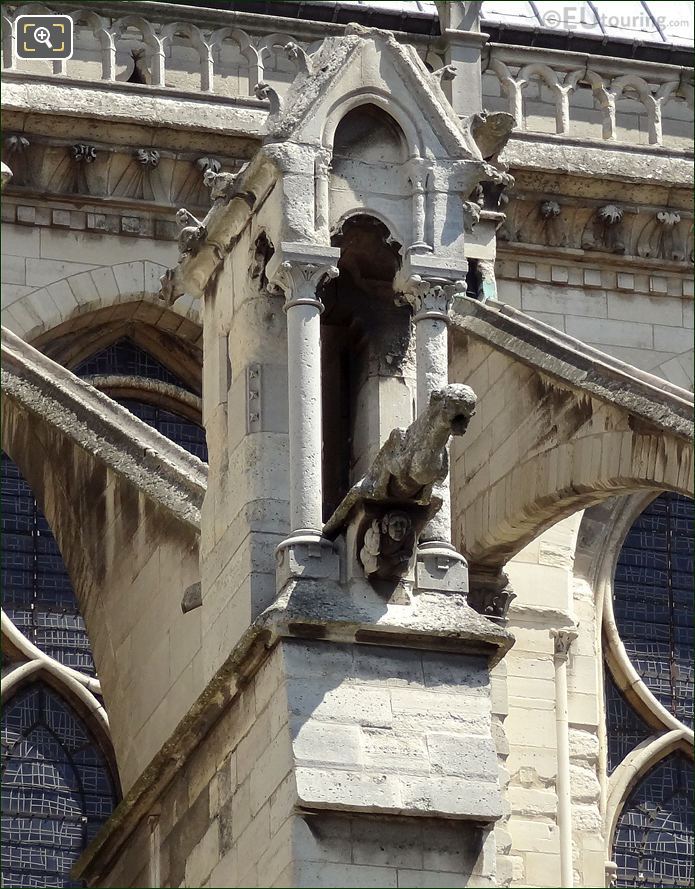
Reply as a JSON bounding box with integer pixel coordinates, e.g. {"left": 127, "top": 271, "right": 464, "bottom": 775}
{"left": 359, "top": 383, "right": 477, "bottom": 502}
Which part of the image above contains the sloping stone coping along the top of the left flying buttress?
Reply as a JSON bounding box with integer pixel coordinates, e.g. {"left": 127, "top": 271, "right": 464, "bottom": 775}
{"left": 2, "top": 327, "right": 207, "bottom": 531}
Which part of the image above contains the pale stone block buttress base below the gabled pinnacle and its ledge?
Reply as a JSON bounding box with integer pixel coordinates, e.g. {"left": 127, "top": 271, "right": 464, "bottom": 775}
{"left": 94, "top": 640, "right": 506, "bottom": 887}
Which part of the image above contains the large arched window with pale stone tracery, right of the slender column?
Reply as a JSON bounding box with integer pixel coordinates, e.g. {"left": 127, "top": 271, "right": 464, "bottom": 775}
{"left": 605, "top": 493, "right": 694, "bottom": 889}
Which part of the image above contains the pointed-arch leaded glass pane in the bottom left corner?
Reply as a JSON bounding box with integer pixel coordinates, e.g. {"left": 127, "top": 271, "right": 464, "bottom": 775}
{"left": 2, "top": 683, "right": 117, "bottom": 887}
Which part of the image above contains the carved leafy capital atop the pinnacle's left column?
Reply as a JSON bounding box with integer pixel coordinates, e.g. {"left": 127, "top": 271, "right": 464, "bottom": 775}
{"left": 266, "top": 244, "right": 340, "bottom": 312}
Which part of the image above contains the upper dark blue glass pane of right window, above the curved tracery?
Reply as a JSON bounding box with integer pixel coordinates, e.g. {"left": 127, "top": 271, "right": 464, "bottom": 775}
{"left": 613, "top": 493, "right": 693, "bottom": 726}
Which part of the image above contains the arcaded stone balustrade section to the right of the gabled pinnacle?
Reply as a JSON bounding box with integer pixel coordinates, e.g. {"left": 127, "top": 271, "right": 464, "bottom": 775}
{"left": 483, "top": 45, "right": 693, "bottom": 147}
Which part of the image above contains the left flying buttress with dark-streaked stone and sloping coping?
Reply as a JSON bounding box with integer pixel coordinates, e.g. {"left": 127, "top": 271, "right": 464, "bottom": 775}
{"left": 2, "top": 328, "right": 207, "bottom": 789}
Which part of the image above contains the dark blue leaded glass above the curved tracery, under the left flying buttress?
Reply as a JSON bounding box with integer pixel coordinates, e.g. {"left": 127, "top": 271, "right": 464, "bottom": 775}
{"left": 0, "top": 453, "right": 95, "bottom": 676}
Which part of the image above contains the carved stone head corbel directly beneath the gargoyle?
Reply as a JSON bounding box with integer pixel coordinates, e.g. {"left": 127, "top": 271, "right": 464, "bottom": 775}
{"left": 346, "top": 501, "right": 430, "bottom": 605}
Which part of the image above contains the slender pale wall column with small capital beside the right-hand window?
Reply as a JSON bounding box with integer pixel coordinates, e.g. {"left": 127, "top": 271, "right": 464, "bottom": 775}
{"left": 550, "top": 628, "right": 577, "bottom": 889}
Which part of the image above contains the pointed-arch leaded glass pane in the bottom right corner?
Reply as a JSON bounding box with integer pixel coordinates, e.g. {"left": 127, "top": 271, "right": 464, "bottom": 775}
{"left": 613, "top": 754, "right": 695, "bottom": 889}
